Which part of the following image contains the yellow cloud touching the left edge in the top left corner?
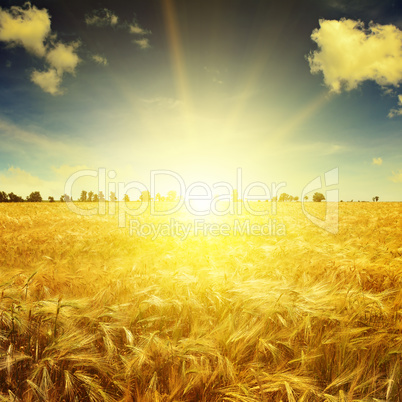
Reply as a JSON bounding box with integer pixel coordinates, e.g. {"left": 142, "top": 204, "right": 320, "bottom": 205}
{"left": 0, "top": 3, "right": 50, "bottom": 57}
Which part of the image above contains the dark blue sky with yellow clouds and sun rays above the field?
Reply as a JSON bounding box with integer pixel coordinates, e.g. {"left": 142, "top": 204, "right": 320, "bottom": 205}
{"left": 0, "top": 0, "right": 402, "bottom": 201}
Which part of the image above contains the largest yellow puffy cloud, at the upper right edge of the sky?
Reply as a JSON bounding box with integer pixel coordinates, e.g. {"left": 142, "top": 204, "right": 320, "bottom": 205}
{"left": 307, "top": 19, "right": 402, "bottom": 93}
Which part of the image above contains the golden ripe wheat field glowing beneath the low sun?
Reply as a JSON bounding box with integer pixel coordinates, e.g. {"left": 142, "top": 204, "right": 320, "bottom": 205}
{"left": 0, "top": 202, "right": 402, "bottom": 402}
